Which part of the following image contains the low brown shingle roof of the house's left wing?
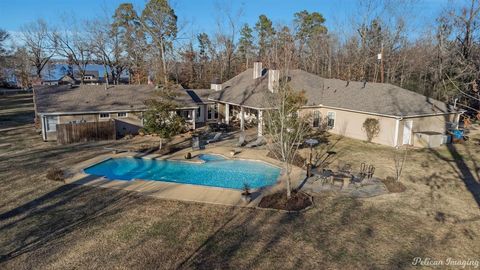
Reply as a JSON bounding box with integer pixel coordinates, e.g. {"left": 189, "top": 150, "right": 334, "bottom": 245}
{"left": 34, "top": 85, "right": 211, "bottom": 113}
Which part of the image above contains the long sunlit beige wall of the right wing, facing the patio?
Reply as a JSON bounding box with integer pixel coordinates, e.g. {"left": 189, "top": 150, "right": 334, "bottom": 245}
{"left": 302, "top": 108, "right": 396, "bottom": 146}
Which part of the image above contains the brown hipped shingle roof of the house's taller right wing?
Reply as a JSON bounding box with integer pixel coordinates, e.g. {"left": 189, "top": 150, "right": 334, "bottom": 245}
{"left": 209, "top": 69, "right": 453, "bottom": 116}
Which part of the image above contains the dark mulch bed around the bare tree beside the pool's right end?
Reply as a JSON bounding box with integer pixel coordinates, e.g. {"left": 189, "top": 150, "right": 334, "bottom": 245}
{"left": 258, "top": 191, "right": 312, "bottom": 211}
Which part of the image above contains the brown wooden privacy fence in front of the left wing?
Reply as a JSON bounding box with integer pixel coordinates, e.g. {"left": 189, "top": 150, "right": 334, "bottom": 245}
{"left": 57, "top": 120, "right": 116, "bottom": 144}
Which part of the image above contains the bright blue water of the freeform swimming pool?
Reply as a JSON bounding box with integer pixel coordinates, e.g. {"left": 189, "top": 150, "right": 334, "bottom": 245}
{"left": 84, "top": 155, "right": 280, "bottom": 189}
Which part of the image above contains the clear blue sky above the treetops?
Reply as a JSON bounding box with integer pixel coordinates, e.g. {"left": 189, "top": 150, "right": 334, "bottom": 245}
{"left": 0, "top": 0, "right": 464, "bottom": 39}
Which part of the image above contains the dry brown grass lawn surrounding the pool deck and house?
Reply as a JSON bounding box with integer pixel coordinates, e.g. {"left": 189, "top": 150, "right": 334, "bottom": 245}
{"left": 0, "top": 92, "right": 480, "bottom": 269}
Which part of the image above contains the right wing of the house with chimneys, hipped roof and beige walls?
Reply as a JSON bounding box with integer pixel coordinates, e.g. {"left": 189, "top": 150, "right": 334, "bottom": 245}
{"left": 209, "top": 62, "right": 460, "bottom": 147}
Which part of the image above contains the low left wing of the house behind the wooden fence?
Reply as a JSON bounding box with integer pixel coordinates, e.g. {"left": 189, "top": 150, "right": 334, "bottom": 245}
{"left": 34, "top": 85, "right": 218, "bottom": 141}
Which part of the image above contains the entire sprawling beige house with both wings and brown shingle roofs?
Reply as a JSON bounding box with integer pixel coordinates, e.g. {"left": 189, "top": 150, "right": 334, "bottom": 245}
{"left": 34, "top": 62, "right": 461, "bottom": 147}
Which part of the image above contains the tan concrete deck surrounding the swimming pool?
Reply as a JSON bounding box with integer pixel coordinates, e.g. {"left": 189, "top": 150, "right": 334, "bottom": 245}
{"left": 66, "top": 145, "right": 306, "bottom": 207}
